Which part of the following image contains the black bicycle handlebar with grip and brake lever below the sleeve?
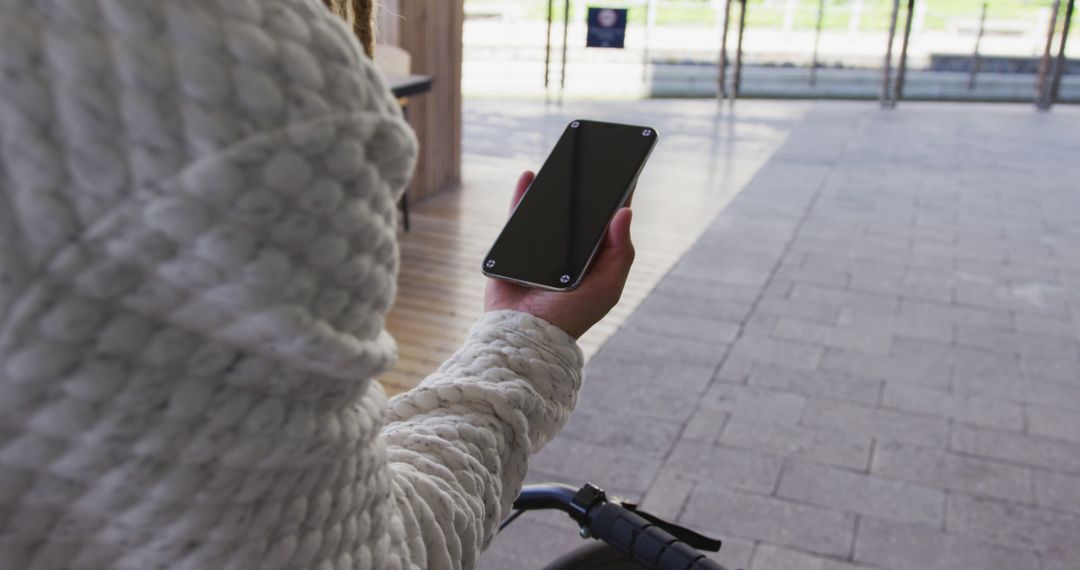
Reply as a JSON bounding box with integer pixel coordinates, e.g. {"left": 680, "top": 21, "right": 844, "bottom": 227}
{"left": 499, "top": 483, "right": 726, "bottom": 570}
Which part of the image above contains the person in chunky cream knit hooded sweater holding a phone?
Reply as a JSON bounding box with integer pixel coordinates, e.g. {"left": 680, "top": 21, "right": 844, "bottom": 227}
{"left": 0, "top": 0, "right": 633, "bottom": 570}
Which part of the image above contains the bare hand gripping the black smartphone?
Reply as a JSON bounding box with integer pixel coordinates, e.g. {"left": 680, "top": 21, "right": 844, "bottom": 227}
{"left": 484, "top": 171, "right": 634, "bottom": 338}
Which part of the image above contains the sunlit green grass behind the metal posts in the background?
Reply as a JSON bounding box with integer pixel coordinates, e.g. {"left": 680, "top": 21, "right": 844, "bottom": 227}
{"left": 465, "top": 0, "right": 1080, "bottom": 30}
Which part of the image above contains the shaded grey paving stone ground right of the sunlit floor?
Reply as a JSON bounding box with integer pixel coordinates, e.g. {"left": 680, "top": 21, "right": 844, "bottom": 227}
{"left": 481, "top": 103, "right": 1080, "bottom": 570}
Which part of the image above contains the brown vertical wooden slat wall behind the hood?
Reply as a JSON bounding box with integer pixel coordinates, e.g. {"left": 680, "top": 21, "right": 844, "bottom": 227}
{"left": 397, "top": 0, "right": 464, "bottom": 202}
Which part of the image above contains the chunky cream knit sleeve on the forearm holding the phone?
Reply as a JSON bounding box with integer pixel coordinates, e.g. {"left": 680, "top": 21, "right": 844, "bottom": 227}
{"left": 383, "top": 311, "right": 582, "bottom": 568}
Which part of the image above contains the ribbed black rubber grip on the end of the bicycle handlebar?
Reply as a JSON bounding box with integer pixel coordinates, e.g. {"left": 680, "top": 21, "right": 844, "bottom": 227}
{"left": 589, "top": 503, "right": 725, "bottom": 570}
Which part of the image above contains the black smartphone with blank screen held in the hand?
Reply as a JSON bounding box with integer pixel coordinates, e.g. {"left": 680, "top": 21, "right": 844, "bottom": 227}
{"left": 482, "top": 120, "right": 658, "bottom": 290}
